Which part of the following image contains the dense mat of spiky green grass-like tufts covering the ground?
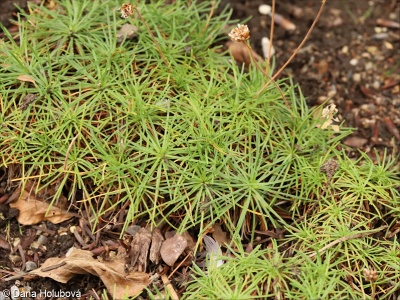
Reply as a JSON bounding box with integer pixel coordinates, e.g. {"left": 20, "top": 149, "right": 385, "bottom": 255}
{"left": 0, "top": 0, "right": 400, "bottom": 299}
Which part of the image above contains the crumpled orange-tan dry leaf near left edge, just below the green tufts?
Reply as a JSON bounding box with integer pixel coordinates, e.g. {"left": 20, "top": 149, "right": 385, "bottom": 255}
{"left": 10, "top": 185, "right": 73, "bottom": 225}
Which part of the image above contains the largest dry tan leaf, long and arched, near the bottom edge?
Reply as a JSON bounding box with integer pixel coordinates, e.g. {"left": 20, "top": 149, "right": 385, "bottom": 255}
{"left": 30, "top": 249, "right": 149, "bottom": 299}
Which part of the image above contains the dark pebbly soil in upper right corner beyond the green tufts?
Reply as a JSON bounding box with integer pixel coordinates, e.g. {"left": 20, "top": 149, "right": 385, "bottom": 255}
{"left": 222, "top": 0, "right": 400, "bottom": 162}
